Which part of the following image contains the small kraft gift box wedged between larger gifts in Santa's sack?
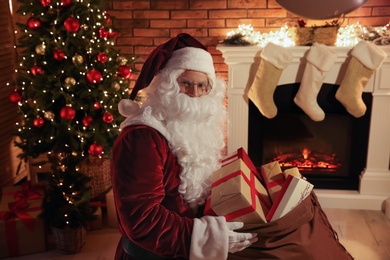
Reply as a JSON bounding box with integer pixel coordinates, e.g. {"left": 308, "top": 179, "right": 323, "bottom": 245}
{"left": 260, "top": 161, "right": 285, "bottom": 202}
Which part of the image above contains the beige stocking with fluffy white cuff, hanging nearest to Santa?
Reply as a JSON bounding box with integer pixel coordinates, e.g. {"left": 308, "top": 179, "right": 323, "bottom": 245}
{"left": 248, "top": 42, "right": 292, "bottom": 118}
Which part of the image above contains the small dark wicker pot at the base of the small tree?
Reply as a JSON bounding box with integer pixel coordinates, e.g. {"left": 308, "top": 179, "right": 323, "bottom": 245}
{"left": 51, "top": 227, "right": 87, "bottom": 254}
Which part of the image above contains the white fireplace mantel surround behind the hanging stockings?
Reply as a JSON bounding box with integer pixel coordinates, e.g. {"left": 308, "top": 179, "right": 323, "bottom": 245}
{"left": 217, "top": 45, "right": 390, "bottom": 210}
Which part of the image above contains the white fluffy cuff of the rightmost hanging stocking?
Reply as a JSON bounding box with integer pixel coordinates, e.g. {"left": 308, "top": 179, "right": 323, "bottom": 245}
{"left": 351, "top": 41, "right": 387, "bottom": 70}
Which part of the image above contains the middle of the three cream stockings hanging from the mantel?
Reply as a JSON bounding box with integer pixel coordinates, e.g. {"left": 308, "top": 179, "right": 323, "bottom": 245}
{"left": 294, "top": 43, "right": 337, "bottom": 121}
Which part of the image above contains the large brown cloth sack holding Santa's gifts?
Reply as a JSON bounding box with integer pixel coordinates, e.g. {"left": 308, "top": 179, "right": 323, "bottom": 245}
{"left": 228, "top": 192, "right": 353, "bottom": 260}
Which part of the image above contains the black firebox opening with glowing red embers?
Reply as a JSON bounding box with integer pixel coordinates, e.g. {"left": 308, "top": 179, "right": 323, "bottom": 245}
{"left": 248, "top": 83, "right": 372, "bottom": 190}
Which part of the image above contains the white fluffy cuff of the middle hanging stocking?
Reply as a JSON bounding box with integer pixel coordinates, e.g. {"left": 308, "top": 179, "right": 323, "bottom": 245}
{"left": 306, "top": 43, "right": 337, "bottom": 71}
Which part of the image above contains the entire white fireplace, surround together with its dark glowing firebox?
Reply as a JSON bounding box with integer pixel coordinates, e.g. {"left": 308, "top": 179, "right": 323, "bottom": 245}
{"left": 217, "top": 45, "right": 390, "bottom": 210}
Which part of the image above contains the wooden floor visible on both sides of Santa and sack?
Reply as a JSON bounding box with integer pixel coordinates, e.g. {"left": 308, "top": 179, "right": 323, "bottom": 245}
{"left": 5, "top": 209, "right": 390, "bottom": 260}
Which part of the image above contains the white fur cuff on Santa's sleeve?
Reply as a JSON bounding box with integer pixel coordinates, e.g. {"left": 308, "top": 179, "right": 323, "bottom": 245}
{"left": 190, "top": 216, "right": 229, "bottom": 260}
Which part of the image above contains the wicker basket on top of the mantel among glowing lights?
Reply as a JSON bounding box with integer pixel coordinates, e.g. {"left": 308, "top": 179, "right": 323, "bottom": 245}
{"left": 295, "top": 26, "right": 339, "bottom": 46}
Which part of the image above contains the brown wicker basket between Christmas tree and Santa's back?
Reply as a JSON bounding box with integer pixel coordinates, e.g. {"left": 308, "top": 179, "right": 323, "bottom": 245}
{"left": 80, "top": 156, "right": 111, "bottom": 199}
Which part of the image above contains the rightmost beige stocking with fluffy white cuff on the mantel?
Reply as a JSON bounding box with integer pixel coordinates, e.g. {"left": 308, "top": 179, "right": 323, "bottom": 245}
{"left": 336, "top": 41, "right": 386, "bottom": 118}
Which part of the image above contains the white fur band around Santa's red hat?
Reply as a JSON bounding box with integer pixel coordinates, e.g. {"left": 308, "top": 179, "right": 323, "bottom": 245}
{"left": 164, "top": 47, "right": 215, "bottom": 81}
